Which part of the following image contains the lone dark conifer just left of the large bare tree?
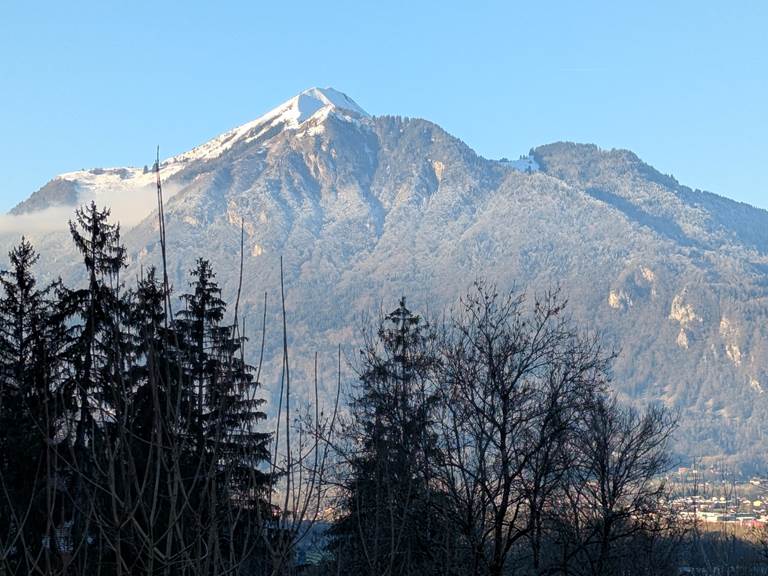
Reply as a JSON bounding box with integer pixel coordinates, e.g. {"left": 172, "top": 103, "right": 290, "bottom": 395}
{"left": 331, "top": 298, "right": 445, "bottom": 575}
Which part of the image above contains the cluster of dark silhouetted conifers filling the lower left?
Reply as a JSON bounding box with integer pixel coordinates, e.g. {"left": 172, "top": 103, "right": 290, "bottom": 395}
{"left": 0, "top": 203, "right": 271, "bottom": 575}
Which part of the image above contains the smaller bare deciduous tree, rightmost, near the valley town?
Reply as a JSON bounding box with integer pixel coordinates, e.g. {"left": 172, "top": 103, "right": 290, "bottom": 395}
{"left": 561, "top": 396, "right": 677, "bottom": 576}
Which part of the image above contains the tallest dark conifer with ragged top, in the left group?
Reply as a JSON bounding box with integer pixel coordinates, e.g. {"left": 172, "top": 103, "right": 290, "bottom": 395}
{"left": 59, "top": 202, "right": 128, "bottom": 558}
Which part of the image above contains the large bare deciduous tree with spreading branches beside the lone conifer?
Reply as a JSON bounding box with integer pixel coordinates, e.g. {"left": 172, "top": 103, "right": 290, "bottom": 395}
{"left": 440, "top": 283, "right": 609, "bottom": 576}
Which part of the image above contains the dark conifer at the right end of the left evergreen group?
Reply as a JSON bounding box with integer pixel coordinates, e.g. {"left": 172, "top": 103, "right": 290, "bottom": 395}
{"left": 175, "top": 258, "right": 270, "bottom": 568}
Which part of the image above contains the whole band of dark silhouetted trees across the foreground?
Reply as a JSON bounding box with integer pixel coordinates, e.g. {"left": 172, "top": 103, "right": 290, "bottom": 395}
{"left": 0, "top": 203, "right": 760, "bottom": 576}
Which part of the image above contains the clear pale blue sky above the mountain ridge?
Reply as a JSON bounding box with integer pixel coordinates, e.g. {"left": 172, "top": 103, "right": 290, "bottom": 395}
{"left": 0, "top": 0, "right": 768, "bottom": 212}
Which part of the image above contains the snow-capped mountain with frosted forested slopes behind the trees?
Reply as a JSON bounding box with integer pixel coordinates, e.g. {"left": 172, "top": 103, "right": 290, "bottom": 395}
{"left": 0, "top": 88, "right": 768, "bottom": 467}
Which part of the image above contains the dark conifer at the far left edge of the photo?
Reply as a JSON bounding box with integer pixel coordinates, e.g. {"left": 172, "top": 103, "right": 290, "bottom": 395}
{"left": 0, "top": 238, "right": 62, "bottom": 573}
